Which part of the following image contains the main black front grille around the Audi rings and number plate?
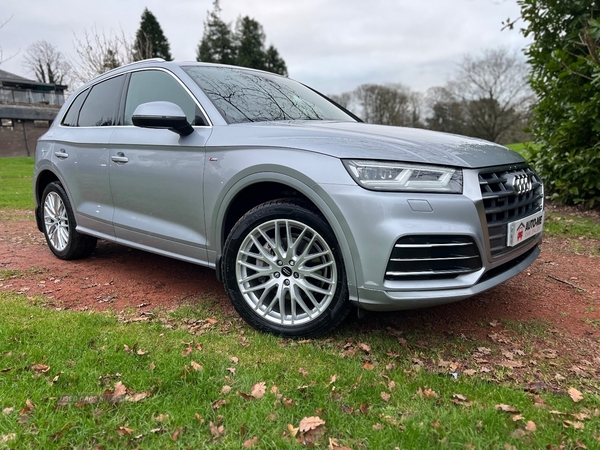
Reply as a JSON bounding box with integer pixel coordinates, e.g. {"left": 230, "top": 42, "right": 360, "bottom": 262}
{"left": 479, "top": 167, "right": 544, "bottom": 256}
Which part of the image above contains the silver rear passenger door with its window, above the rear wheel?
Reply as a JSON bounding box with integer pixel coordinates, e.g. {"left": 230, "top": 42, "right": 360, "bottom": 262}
{"left": 52, "top": 75, "right": 125, "bottom": 239}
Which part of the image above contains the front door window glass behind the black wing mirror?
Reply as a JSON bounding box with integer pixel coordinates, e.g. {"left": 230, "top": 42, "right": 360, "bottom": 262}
{"left": 124, "top": 70, "right": 205, "bottom": 125}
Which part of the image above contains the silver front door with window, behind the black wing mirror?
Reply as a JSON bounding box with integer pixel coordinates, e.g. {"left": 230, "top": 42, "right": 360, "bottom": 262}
{"left": 110, "top": 69, "right": 212, "bottom": 262}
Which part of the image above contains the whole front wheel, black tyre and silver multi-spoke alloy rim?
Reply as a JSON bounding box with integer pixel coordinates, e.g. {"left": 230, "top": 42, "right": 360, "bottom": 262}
{"left": 223, "top": 200, "right": 350, "bottom": 338}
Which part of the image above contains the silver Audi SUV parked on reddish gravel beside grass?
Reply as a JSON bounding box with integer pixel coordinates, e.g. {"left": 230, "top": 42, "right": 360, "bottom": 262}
{"left": 34, "top": 60, "right": 544, "bottom": 337}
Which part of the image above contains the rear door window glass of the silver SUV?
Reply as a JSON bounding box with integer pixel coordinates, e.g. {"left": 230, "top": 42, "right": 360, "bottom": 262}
{"left": 78, "top": 75, "right": 125, "bottom": 127}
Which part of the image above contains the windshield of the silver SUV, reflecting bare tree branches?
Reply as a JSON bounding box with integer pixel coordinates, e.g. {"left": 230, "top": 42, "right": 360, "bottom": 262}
{"left": 183, "top": 66, "right": 355, "bottom": 123}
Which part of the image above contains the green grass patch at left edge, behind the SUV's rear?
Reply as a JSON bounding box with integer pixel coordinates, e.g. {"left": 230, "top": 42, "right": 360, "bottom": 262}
{"left": 0, "top": 158, "right": 35, "bottom": 210}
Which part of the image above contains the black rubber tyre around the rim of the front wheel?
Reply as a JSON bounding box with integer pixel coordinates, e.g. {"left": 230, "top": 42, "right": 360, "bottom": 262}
{"left": 223, "top": 200, "right": 350, "bottom": 338}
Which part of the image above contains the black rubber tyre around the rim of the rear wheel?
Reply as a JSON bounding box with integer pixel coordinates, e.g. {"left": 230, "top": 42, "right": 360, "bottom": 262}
{"left": 40, "top": 182, "right": 96, "bottom": 260}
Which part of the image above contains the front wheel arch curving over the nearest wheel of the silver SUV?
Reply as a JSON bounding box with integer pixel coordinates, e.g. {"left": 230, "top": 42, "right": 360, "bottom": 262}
{"left": 214, "top": 172, "right": 358, "bottom": 301}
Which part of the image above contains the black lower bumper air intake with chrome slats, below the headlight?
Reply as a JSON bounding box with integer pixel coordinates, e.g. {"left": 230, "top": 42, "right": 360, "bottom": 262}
{"left": 385, "top": 236, "right": 482, "bottom": 281}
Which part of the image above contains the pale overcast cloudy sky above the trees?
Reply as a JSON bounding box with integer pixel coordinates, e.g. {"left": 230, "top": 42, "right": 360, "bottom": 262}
{"left": 0, "top": 0, "right": 527, "bottom": 94}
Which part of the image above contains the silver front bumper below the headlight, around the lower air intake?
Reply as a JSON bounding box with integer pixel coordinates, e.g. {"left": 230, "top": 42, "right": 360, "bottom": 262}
{"left": 326, "top": 166, "right": 542, "bottom": 311}
